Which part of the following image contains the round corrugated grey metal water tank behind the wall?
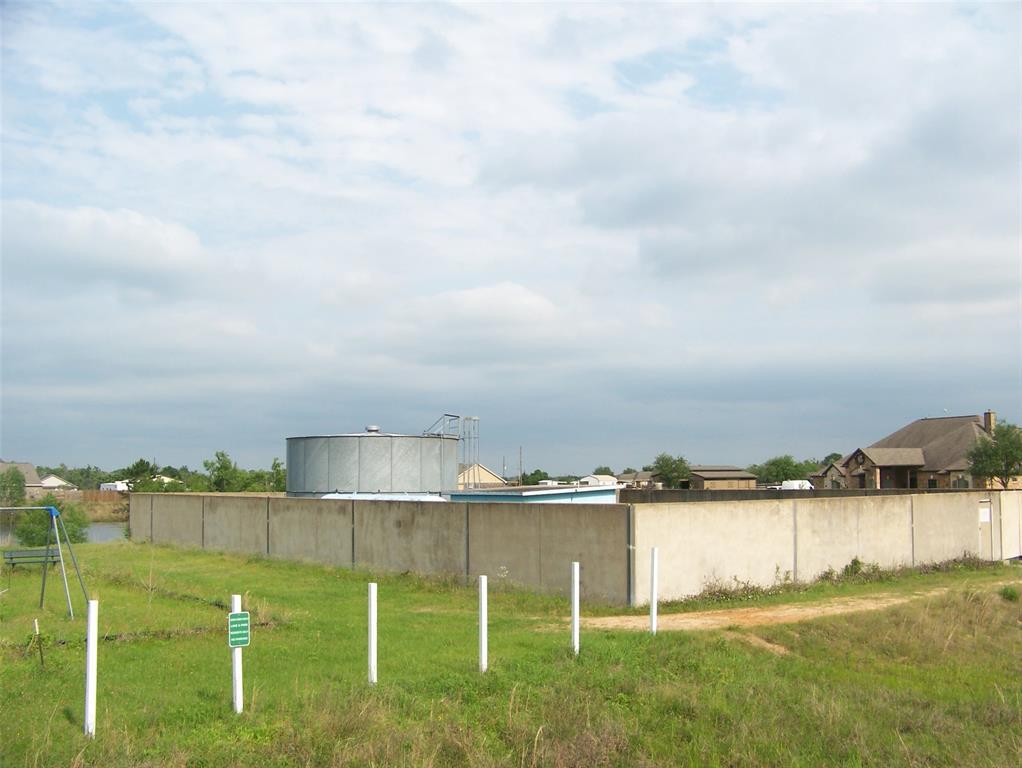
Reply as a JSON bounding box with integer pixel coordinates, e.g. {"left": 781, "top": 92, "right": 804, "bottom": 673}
{"left": 287, "top": 425, "right": 458, "bottom": 496}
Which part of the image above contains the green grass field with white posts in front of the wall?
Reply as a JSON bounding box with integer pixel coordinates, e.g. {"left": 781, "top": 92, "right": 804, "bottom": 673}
{"left": 0, "top": 542, "right": 1022, "bottom": 768}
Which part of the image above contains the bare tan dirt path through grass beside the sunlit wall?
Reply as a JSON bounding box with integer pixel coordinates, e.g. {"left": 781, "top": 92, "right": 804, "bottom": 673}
{"left": 582, "top": 581, "right": 1015, "bottom": 632}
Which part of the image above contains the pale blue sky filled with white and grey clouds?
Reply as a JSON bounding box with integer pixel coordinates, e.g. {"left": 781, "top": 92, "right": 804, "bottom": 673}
{"left": 0, "top": 2, "right": 1022, "bottom": 473}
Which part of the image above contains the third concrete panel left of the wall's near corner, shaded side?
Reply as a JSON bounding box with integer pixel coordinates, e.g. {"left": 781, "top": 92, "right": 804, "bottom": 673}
{"left": 270, "top": 499, "right": 355, "bottom": 568}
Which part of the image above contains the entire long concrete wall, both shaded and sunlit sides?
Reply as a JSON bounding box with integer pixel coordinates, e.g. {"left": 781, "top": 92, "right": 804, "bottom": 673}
{"left": 130, "top": 491, "right": 1022, "bottom": 604}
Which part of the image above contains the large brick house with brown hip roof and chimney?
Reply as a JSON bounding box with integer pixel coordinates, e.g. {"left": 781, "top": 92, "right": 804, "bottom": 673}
{"left": 818, "top": 411, "right": 1022, "bottom": 488}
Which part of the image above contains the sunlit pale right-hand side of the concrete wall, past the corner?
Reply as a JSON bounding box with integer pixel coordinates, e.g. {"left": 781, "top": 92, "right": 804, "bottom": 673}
{"left": 632, "top": 491, "right": 1022, "bottom": 604}
